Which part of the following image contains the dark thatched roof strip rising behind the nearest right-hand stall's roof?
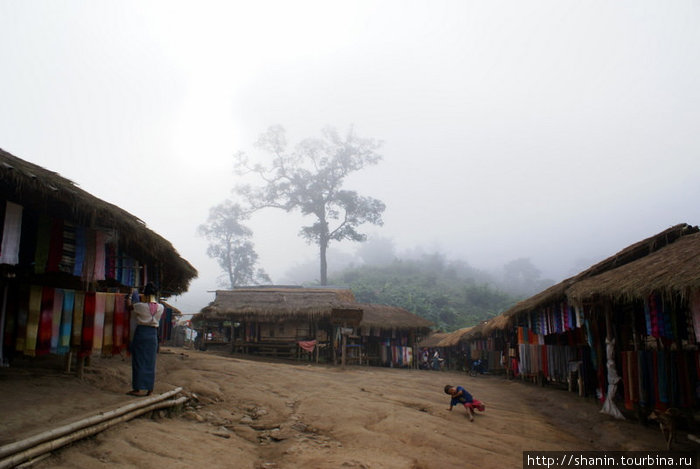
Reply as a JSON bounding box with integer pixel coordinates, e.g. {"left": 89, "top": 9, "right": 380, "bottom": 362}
{"left": 498, "top": 223, "right": 700, "bottom": 327}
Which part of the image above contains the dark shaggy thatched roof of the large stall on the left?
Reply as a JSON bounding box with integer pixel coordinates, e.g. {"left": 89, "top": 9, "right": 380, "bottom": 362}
{"left": 0, "top": 149, "right": 197, "bottom": 296}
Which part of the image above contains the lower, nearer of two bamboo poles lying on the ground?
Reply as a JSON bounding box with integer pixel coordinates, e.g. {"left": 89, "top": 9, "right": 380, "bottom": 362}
{"left": 0, "top": 396, "right": 187, "bottom": 469}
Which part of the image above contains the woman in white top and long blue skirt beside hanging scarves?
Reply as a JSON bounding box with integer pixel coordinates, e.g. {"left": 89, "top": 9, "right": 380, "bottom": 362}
{"left": 127, "top": 282, "right": 165, "bottom": 396}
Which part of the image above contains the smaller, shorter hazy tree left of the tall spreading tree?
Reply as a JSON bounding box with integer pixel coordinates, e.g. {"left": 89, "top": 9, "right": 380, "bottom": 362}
{"left": 199, "top": 200, "right": 270, "bottom": 288}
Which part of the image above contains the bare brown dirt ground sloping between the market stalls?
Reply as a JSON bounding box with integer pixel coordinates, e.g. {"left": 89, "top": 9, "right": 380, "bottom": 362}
{"left": 0, "top": 348, "right": 698, "bottom": 469}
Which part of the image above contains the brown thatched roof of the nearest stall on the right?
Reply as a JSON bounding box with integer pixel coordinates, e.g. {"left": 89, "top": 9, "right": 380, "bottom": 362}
{"left": 566, "top": 232, "right": 700, "bottom": 301}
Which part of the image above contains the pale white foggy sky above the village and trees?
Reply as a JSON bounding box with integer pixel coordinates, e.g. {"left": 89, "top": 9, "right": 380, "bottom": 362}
{"left": 0, "top": 0, "right": 700, "bottom": 313}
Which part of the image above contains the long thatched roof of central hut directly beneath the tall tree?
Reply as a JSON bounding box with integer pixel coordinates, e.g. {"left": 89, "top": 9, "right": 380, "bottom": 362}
{"left": 195, "top": 287, "right": 360, "bottom": 322}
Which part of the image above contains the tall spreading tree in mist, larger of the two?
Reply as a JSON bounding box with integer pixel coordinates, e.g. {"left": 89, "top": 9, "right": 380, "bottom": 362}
{"left": 235, "top": 126, "right": 385, "bottom": 285}
